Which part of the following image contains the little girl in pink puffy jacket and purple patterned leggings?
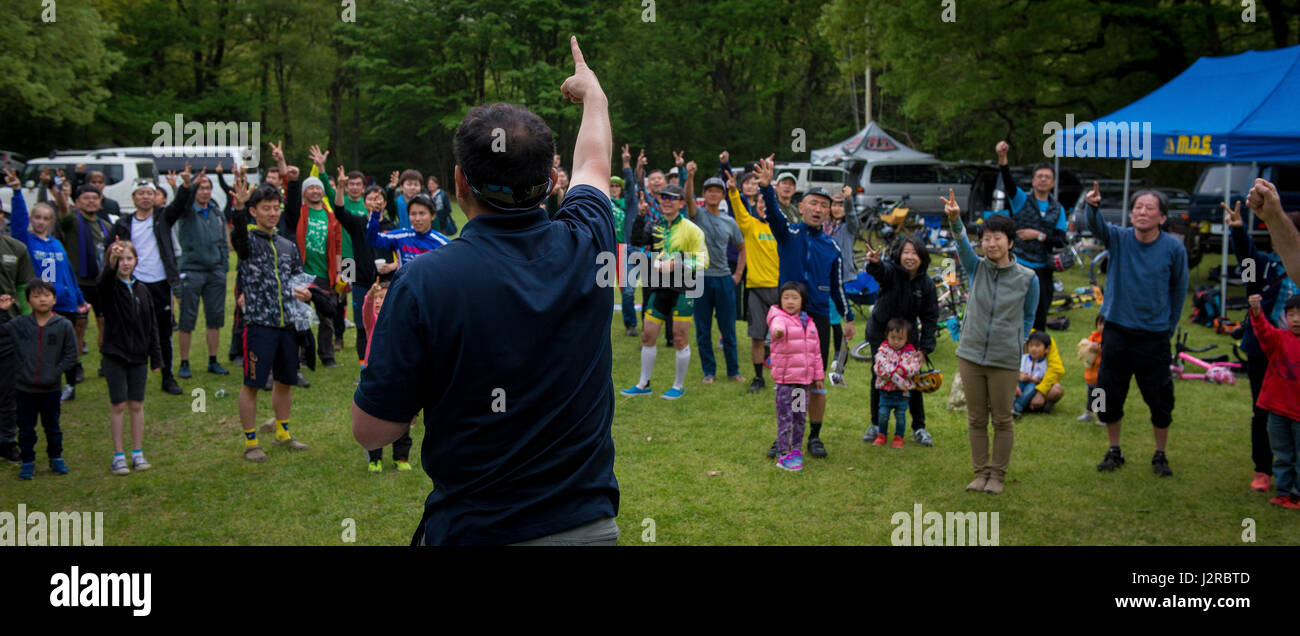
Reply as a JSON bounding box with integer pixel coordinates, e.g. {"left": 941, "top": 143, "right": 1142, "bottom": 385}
{"left": 767, "top": 281, "right": 826, "bottom": 471}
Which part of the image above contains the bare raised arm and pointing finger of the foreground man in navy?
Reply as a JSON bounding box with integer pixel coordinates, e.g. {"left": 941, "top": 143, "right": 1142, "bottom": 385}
{"left": 560, "top": 36, "right": 614, "bottom": 196}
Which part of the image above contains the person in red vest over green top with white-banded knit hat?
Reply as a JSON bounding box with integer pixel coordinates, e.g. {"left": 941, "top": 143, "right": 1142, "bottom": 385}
{"left": 272, "top": 139, "right": 345, "bottom": 368}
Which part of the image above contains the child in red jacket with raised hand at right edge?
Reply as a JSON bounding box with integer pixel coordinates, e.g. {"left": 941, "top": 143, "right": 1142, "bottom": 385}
{"left": 1249, "top": 294, "right": 1300, "bottom": 509}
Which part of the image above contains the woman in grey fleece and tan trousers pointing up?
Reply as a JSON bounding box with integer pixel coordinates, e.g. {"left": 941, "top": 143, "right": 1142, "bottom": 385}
{"left": 940, "top": 190, "right": 1039, "bottom": 494}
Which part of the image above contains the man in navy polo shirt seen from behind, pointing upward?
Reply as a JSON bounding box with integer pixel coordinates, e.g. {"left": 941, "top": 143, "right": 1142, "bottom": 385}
{"left": 352, "top": 38, "right": 619, "bottom": 545}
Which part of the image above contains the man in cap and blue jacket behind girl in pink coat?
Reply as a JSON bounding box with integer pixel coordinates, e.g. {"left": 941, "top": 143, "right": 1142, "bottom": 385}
{"left": 758, "top": 156, "right": 854, "bottom": 458}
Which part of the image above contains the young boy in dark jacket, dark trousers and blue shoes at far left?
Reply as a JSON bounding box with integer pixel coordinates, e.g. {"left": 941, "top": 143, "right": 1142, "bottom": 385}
{"left": 0, "top": 278, "right": 77, "bottom": 479}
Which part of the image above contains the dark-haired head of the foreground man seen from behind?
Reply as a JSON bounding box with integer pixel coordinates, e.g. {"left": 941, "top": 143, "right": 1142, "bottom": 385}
{"left": 454, "top": 103, "right": 555, "bottom": 212}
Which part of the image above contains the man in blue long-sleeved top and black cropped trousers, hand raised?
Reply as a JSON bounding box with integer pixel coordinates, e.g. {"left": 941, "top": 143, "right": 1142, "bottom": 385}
{"left": 1084, "top": 181, "right": 1188, "bottom": 477}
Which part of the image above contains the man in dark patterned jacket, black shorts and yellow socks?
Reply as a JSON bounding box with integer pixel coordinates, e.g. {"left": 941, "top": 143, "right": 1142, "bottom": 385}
{"left": 230, "top": 181, "right": 311, "bottom": 462}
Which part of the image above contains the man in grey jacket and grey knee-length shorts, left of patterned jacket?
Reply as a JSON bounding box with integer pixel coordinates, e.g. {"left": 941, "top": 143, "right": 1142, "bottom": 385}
{"left": 163, "top": 164, "right": 230, "bottom": 380}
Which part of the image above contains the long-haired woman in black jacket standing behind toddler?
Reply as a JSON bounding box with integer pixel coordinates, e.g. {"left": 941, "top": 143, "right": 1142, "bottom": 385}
{"left": 862, "top": 237, "right": 939, "bottom": 446}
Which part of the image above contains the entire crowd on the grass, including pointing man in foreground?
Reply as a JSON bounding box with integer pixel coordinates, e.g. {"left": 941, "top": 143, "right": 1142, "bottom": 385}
{"left": 0, "top": 34, "right": 1300, "bottom": 544}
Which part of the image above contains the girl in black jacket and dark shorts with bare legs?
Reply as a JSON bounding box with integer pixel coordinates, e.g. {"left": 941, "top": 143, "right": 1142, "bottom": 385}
{"left": 95, "top": 239, "right": 163, "bottom": 475}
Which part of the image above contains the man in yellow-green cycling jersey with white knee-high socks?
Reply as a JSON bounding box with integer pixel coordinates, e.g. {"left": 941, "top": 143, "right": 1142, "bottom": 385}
{"left": 620, "top": 178, "right": 709, "bottom": 399}
